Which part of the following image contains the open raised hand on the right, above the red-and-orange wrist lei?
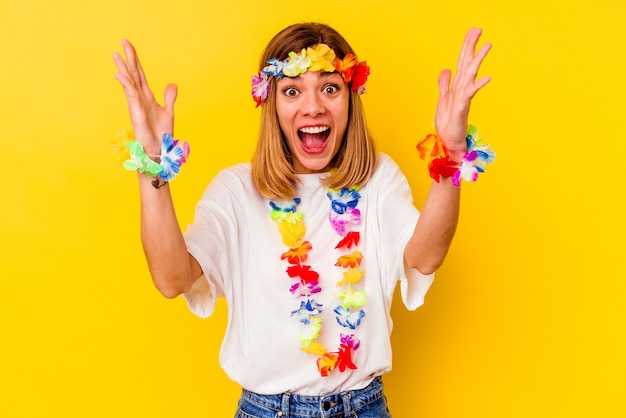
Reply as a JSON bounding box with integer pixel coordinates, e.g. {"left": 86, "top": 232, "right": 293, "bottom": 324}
{"left": 435, "top": 28, "right": 491, "bottom": 161}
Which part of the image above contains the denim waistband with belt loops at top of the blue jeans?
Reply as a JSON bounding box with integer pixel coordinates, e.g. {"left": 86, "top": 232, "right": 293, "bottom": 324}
{"left": 241, "top": 376, "right": 384, "bottom": 417}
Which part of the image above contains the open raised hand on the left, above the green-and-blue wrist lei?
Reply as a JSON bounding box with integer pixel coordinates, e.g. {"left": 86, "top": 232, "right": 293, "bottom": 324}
{"left": 113, "top": 40, "right": 178, "bottom": 155}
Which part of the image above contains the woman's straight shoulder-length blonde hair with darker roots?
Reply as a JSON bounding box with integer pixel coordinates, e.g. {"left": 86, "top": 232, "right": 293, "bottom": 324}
{"left": 252, "top": 23, "right": 376, "bottom": 199}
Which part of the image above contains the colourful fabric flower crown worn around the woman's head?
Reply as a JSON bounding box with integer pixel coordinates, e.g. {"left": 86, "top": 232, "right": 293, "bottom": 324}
{"left": 252, "top": 44, "right": 370, "bottom": 107}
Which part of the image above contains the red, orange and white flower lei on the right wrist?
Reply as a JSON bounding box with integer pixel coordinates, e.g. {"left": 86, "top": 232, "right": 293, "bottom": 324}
{"left": 417, "top": 125, "right": 496, "bottom": 187}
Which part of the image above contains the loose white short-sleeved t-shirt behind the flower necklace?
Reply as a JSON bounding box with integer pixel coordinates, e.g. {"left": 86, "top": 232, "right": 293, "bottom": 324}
{"left": 184, "top": 154, "right": 434, "bottom": 395}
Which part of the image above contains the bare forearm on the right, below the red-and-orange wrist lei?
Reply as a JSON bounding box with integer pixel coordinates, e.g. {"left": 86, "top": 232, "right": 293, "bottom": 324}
{"left": 404, "top": 178, "right": 461, "bottom": 274}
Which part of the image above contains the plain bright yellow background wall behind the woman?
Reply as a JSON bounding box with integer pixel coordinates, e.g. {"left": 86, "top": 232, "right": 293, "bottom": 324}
{"left": 0, "top": 0, "right": 626, "bottom": 418}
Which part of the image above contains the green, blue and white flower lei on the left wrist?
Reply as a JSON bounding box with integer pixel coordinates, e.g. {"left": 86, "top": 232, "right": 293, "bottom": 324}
{"left": 124, "top": 133, "right": 189, "bottom": 189}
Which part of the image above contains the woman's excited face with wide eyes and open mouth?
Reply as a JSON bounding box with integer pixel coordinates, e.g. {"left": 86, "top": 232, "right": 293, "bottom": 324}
{"left": 276, "top": 71, "right": 350, "bottom": 174}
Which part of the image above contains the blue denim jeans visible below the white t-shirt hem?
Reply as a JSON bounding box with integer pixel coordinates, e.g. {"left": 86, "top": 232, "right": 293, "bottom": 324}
{"left": 235, "top": 376, "right": 391, "bottom": 418}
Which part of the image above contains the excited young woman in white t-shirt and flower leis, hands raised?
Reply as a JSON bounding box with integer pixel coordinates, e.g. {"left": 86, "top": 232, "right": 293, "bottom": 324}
{"left": 114, "top": 23, "right": 491, "bottom": 418}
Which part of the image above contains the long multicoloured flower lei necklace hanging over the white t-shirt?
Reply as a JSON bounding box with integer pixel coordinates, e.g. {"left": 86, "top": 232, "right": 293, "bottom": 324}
{"left": 270, "top": 186, "right": 366, "bottom": 377}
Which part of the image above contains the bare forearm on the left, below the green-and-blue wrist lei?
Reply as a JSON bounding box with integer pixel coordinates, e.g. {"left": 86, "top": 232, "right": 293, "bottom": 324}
{"left": 139, "top": 174, "right": 196, "bottom": 298}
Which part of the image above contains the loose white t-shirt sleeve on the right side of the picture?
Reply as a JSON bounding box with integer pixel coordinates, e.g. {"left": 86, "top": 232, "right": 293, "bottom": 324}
{"left": 379, "top": 156, "right": 435, "bottom": 310}
